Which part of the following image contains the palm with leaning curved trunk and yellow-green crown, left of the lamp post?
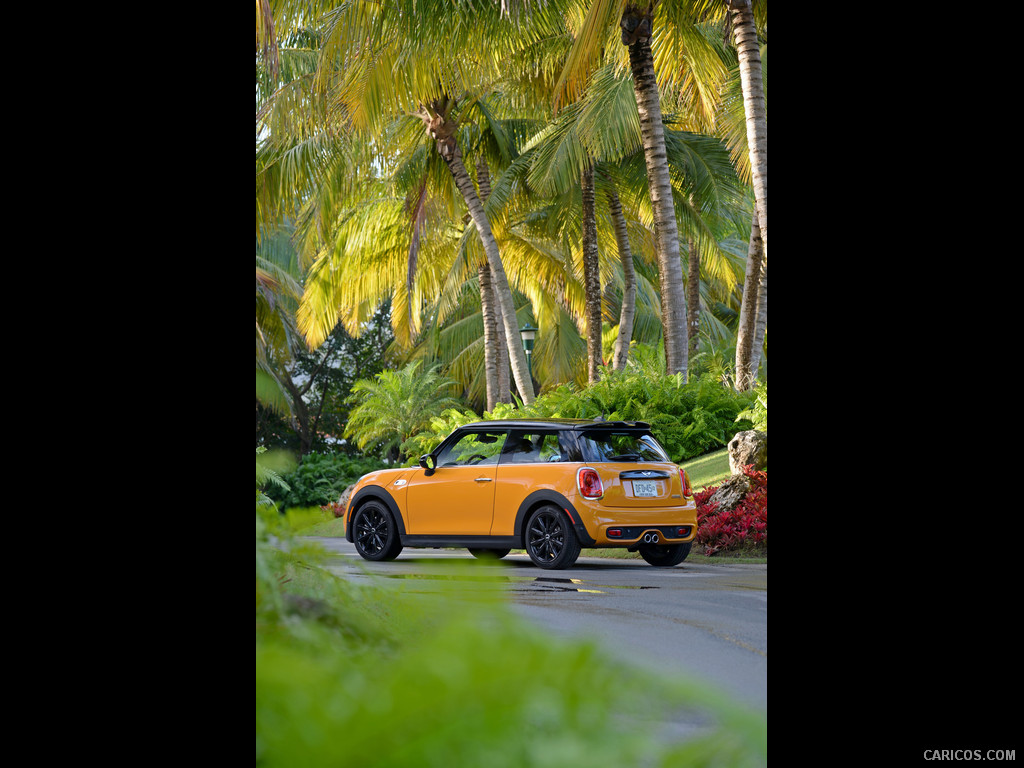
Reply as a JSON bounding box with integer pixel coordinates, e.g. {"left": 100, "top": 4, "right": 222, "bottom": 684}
{"left": 258, "top": 0, "right": 573, "bottom": 402}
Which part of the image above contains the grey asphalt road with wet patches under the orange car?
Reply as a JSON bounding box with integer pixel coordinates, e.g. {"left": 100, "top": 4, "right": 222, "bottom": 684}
{"left": 313, "top": 538, "right": 768, "bottom": 713}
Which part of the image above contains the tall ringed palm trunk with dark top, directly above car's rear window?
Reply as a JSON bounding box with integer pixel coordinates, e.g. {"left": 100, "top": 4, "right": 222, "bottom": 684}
{"left": 621, "top": 5, "right": 687, "bottom": 381}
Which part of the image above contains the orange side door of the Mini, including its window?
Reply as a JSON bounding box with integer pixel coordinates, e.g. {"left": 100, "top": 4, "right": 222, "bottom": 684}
{"left": 407, "top": 430, "right": 506, "bottom": 536}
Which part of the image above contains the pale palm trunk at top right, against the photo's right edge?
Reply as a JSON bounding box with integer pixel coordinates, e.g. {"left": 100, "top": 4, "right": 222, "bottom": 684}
{"left": 725, "top": 0, "right": 768, "bottom": 270}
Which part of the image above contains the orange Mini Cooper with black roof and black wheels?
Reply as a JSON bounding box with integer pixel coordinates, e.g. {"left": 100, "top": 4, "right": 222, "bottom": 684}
{"left": 345, "top": 419, "right": 697, "bottom": 568}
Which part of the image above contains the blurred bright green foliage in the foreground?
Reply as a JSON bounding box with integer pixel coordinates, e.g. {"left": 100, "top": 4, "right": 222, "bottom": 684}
{"left": 256, "top": 515, "right": 767, "bottom": 768}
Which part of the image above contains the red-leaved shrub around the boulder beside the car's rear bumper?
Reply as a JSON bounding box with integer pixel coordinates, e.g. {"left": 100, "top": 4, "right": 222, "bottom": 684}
{"left": 693, "top": 465, "right": 768, "bottom": 557}
